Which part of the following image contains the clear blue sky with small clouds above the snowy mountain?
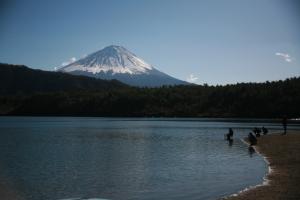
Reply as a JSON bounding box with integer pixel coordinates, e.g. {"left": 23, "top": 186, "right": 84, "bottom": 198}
{"left": 0, "top": 0, "right": 300, "bottom": 84}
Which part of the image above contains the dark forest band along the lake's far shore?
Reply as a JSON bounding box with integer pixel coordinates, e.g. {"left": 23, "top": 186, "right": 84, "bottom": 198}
{"left": 0, "top": 63, "right": 300, "bottom": 118}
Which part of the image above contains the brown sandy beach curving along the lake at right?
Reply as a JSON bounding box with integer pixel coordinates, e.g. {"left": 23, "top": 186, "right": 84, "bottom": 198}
{"left": 226, "top": 132, "right": 300, "bottom": 200}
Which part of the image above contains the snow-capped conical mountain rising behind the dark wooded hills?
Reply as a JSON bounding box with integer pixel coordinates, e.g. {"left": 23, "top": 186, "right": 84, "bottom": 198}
{"left": 58, "top": 45, "right": 189, "bottom": 87}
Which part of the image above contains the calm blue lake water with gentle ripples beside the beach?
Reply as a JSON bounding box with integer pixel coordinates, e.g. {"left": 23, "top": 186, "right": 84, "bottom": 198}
{"left": 0, "top": 117, "right": 299, "bottom": 200}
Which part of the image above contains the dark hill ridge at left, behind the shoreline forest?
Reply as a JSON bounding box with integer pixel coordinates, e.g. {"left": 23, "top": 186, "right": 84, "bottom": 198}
{"left": 0, "top": 63, "right": 127, "bottom": 94}
